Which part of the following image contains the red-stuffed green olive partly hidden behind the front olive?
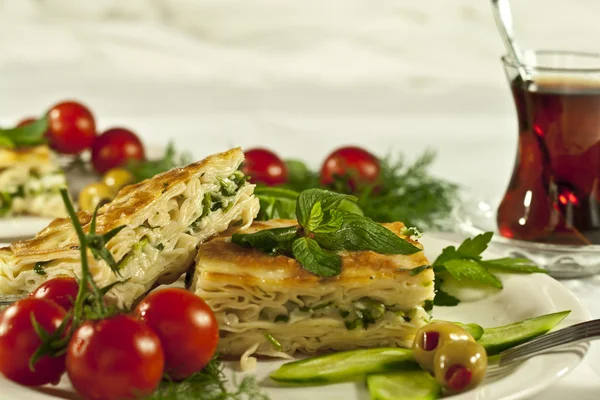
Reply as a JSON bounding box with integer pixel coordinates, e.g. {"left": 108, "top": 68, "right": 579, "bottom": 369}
{"left": 413, "top": 321, "right": 475, "bottom": 372}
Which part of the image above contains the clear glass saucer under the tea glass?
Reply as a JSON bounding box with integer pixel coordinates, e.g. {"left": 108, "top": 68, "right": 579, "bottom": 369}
{"left": 455, "top": 197, "right": 600, "bottom": 279}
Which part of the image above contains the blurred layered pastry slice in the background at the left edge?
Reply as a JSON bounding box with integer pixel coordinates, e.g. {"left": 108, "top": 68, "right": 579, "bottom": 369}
{"left": 0, "top": 145, "right": 67, "bottom": 218}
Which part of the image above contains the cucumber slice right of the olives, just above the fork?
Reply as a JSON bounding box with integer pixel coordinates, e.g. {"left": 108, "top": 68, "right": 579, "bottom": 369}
{"left": 478, "top": 311, "right": 571, "bottom": 356}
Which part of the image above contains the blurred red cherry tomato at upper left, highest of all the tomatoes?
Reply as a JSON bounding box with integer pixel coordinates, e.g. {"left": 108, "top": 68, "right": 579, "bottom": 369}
{"left": 46, "top": 101, "right": 96, "bottom": 154}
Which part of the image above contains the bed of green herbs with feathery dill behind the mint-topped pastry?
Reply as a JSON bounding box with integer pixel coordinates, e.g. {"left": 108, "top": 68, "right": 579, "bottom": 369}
{"left": 256, "top": 151, "right": 458, "bottom": 229}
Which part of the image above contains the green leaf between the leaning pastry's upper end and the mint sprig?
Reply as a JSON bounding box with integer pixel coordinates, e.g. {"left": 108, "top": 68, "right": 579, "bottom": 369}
{"left": 254, "top": 187, "right": 298, "bottom": 221}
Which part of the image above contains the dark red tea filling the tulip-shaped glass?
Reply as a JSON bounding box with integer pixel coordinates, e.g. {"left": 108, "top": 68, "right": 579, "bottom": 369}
{"left": 497, "top": 78, "right": 600, "bottom": 244}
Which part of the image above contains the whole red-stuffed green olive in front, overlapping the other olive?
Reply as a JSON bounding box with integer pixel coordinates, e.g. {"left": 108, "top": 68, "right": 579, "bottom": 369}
{"left": 433, "top": 341, "right": 487, "bottom": 393}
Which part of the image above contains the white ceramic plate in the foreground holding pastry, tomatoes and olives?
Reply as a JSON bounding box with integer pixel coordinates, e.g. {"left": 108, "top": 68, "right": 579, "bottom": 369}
{"left": 0, "top": 237, "right": 590, "bottom": 400}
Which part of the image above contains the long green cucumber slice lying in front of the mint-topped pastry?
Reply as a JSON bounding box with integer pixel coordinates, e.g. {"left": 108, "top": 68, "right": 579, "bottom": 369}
{"left": 270, "top": 347, "right": 419, "bottom": 384}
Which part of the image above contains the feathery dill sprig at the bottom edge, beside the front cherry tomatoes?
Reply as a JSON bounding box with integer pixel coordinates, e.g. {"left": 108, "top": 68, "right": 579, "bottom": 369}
{"left": 148, "top": 356, "right": 269, "bottom": 400}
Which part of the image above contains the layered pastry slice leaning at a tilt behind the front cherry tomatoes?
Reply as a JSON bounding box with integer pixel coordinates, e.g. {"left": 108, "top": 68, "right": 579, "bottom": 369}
{"left": 0, "top": 148, "right": 259, "bottom": 307}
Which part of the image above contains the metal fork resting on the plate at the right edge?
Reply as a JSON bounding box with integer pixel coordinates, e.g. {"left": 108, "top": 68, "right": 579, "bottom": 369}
{"left": 499, "top": 320, "right": 600, "bottom": 366}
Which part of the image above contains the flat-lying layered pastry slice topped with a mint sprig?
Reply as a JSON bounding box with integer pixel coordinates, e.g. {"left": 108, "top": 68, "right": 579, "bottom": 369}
{"left": 188, "top": 220, "right": 434, "bottom": 369}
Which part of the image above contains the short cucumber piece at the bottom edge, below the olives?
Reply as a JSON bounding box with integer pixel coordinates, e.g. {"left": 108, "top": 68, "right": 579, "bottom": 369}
{"left": 367, "top": 370, "right": 442, "bottom": 400}
